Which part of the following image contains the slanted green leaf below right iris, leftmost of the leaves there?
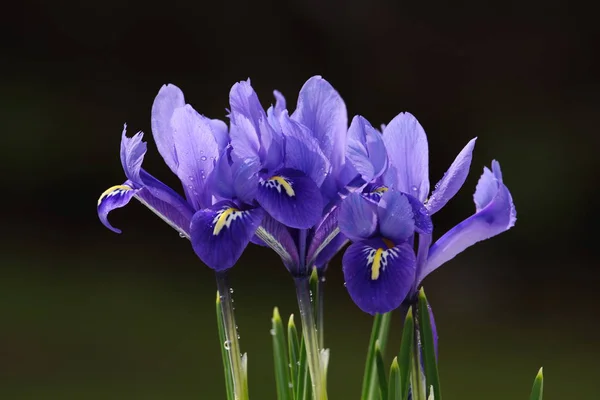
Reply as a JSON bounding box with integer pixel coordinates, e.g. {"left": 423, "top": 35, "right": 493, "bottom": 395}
{"left": 360, "top": 312, "right": 392, "bottom": 400}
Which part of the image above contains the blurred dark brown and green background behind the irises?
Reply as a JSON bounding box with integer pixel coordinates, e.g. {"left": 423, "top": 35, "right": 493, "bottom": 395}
{"left": 0, "top": 0, "right": 600, "bottom": 400}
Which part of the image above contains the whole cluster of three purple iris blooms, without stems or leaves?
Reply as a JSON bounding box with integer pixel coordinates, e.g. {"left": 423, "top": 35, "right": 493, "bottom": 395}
{"left": 98, "top": 76, "right": 516, "bottom": 314}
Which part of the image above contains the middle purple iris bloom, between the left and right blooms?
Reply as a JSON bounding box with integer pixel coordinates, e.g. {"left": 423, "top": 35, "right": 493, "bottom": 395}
{"left": 225, "top": 76, "right": 360, "bottom": 276}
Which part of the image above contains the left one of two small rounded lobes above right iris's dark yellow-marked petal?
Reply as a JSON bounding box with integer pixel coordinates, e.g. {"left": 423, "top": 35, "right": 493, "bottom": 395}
{"left": 338, "top": 193, "right": 377, "bottom": 241}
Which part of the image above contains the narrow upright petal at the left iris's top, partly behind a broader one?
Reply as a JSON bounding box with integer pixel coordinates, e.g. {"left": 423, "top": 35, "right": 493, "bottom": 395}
{"left": 151, "top": 84, "right": 185, "bottom": 174}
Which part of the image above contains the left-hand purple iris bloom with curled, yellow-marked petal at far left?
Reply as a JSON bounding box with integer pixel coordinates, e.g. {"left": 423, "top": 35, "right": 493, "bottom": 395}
{"left": 98, "top": 85, "right": 264, "bottom": 270}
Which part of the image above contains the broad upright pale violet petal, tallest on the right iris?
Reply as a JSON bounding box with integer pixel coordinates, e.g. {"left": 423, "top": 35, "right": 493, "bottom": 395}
{"left": 383, "top": 113, "right": 429, "bottom": 202}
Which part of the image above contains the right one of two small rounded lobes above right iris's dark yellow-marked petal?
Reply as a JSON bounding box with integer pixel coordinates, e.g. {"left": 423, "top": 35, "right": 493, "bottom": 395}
{"left": 377, "top": 190, "right": 415, "bottom": 243}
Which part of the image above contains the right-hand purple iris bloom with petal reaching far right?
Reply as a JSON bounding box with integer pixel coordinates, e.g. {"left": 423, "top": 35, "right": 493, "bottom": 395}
{"left": 339, "top": 113, "right": 516, "bottom": 314}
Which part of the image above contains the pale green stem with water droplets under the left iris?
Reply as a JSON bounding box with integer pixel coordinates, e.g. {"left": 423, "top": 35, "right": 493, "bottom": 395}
{"left": 216, "top": 271, "right": 248, "bottom": 400}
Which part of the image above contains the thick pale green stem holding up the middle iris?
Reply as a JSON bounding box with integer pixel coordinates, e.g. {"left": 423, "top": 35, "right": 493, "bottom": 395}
{"left": 295, "top": 277, "right": 327, "bottom": 400}
